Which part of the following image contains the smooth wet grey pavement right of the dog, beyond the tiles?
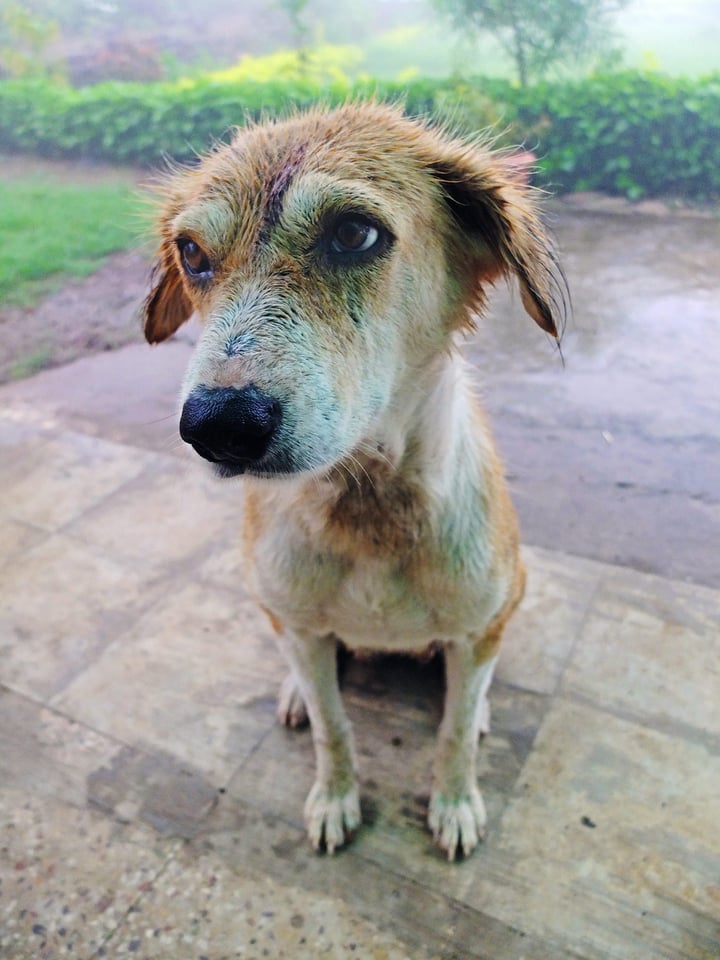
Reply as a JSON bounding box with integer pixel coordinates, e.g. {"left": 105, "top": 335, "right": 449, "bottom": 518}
{"left": 469, "top": 204, "right": 720, "bottom": 587}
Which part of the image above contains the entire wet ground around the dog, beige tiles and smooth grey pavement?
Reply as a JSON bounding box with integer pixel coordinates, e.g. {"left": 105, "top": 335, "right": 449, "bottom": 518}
{"left": 0, "top": 199, "right": 720, "bottom": 960}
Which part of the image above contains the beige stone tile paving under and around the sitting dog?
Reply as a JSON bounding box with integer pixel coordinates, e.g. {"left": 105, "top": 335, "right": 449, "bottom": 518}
{"left": 0, "top": 339, "right": 720, "bottom": 960}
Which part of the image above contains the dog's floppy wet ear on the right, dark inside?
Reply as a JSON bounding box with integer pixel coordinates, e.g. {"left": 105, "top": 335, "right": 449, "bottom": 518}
{"left": 429, "top": 137, "right": 567, "bottom": 339}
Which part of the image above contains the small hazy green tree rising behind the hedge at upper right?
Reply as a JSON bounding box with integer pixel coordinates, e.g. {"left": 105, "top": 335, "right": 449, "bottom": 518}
{"left": 435, "top": 0, "right": 629, "bottom": 86}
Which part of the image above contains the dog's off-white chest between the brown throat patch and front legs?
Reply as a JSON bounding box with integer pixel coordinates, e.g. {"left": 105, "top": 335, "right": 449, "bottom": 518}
{"left": 248, "top": 480, "right": 494, "bottom": 650}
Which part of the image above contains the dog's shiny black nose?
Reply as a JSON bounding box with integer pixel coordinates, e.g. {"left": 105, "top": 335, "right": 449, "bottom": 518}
{"left": 180, "top": 384, "right": 282, "bottom": 467}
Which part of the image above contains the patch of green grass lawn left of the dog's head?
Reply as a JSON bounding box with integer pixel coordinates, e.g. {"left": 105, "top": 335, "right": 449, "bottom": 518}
{"left": 0, "top": 169, "right": 142, "bottom": 306}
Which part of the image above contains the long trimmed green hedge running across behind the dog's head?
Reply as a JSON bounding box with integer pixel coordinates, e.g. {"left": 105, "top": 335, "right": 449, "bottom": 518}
{"left": 0, "top": 72, "right": 720, "bottom": 200}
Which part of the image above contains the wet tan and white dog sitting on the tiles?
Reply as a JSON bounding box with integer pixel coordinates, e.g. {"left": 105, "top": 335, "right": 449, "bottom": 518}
{"left": 144, "top": 102, "right": 564, "bottom": 860}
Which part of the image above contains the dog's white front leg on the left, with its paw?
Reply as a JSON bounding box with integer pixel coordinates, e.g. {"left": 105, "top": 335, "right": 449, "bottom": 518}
{"left": 280, "top": 632, "right": 360, "bottom": 853}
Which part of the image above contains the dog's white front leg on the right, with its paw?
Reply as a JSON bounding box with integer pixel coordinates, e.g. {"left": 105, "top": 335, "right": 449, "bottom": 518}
{"left": 428, "top": 638, "right": 497, "bottom": 860}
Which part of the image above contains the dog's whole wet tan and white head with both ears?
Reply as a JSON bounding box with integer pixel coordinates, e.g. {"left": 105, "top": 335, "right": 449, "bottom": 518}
{"left": 145, "top": 104, "right": 557, "bottom": 476}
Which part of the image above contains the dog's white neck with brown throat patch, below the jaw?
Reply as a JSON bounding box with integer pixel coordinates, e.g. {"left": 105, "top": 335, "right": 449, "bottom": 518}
{"left": 278, "top": 344, "right": 492, "bottom": 562}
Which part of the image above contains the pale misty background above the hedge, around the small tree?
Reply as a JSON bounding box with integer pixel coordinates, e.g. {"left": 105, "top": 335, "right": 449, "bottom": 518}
{"left": 0, "top": 0, "right": 720, "bottom": 86}
